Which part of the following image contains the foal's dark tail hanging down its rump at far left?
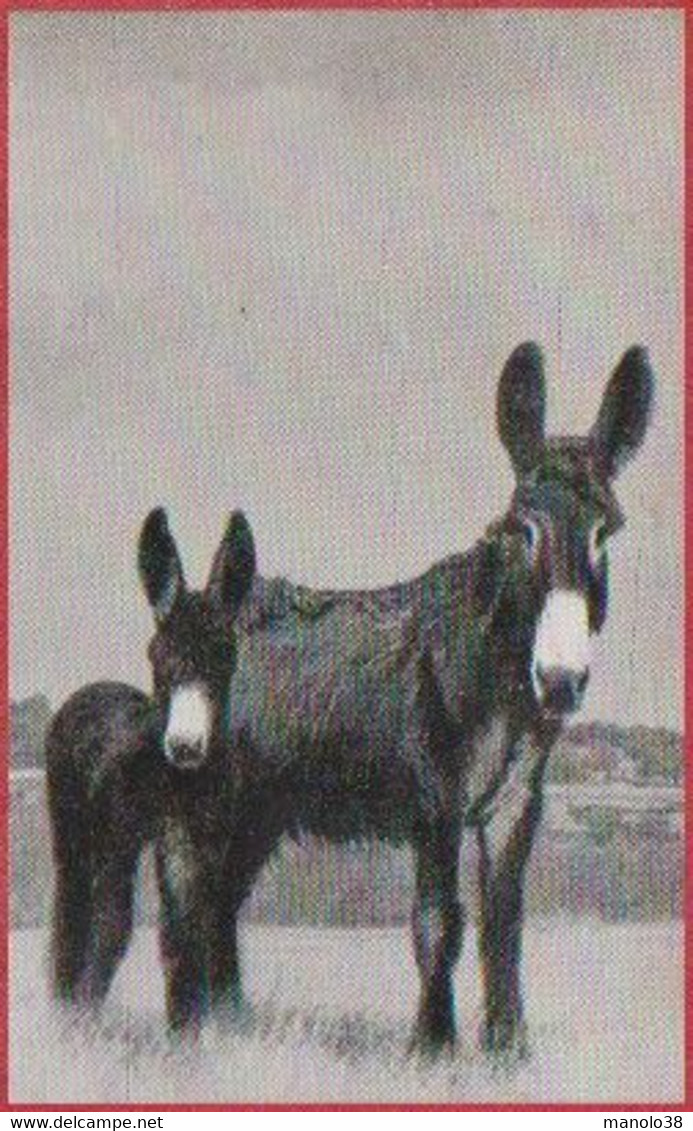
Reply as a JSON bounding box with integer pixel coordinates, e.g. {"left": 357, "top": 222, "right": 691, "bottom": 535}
{"left": 45, "top": 716, "right": 92, "bottom": 1003}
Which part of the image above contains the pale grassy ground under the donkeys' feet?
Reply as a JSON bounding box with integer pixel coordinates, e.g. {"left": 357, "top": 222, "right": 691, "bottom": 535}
{"left": 10, "top": 921, "right": 683, "bottom": 1104}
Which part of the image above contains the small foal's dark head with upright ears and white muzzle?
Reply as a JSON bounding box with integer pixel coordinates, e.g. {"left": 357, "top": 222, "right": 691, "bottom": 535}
{"left": 138, "top": 508, "right": 255, "bottom": 769}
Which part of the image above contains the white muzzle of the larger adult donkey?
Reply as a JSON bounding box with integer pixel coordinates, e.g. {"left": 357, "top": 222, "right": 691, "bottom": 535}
{"left": 531, "top": 589, "right": 591, "bottom": 716}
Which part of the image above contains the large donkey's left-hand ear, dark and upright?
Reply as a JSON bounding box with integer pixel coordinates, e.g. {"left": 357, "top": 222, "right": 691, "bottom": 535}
{"left": 496, "top": 342, "right": 546, "bottom": 475}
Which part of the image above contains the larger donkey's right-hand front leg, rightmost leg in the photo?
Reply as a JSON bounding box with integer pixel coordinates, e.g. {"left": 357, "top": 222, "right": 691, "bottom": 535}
{"left": 478, "top": 782, "right": 542, "bottom": 1056}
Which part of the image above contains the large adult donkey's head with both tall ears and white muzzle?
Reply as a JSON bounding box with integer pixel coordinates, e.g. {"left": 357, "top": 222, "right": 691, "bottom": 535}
{"left": 497, "top": 343, "right": 653, "bottom": 716}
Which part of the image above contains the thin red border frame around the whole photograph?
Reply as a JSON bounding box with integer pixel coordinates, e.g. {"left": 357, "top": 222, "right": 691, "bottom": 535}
{"left": 0, "top": 0, "right": 693, "bottom": 1114}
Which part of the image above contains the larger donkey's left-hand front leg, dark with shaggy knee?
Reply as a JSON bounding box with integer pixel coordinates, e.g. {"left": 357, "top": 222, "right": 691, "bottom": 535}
{"left": 413, "top": 820, "right": 464, "bottom": 1054}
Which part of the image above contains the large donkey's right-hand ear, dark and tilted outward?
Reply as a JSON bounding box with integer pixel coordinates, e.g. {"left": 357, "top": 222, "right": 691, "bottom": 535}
{"left": 590, "top": 346, "right": 655, "bottom": 478}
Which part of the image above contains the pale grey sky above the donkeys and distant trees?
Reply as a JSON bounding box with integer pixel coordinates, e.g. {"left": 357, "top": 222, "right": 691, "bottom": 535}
{"left": 10, "top": 10, "right": 684, "bottom": 727}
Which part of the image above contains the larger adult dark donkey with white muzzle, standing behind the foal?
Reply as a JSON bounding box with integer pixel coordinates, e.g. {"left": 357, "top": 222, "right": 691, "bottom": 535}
{"left": 191, "top": 344, "right": 653, "bottom": 1052}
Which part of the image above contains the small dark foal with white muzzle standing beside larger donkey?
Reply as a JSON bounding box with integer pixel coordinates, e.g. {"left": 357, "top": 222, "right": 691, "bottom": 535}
{"left": 45, "top": 509, "right": 255, "bottom": 1026}
